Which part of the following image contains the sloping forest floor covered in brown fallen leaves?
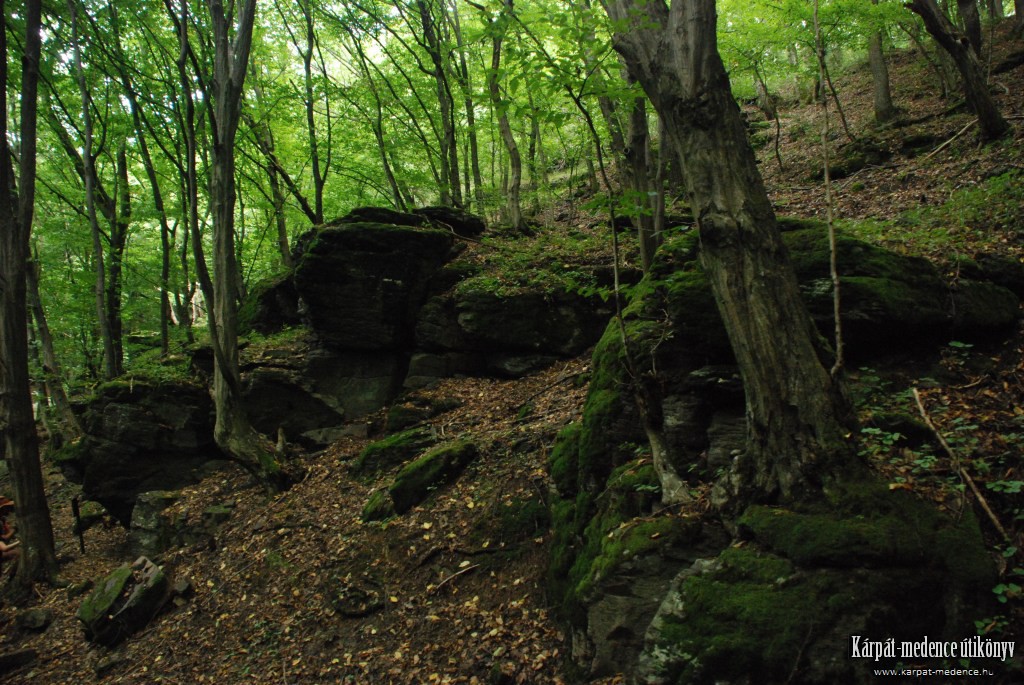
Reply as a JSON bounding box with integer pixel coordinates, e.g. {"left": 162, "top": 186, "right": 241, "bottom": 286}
{"left": 6, "top": 18, "right": 1024, "bottom": 685}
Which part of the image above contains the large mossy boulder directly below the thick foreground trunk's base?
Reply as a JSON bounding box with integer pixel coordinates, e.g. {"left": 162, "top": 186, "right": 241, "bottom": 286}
{"left": 638, "top": 482, "right": 995, "bottom": 684}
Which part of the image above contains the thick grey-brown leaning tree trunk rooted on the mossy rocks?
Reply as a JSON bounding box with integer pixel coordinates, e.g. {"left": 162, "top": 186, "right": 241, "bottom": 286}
{"left": 604, "top": 0, "right": 855, "bottom": 499}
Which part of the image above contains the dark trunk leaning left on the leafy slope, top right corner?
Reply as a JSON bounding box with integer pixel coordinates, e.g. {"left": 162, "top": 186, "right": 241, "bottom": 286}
{"left": 906, "top": 0, "right": 1010, "bottom": 141}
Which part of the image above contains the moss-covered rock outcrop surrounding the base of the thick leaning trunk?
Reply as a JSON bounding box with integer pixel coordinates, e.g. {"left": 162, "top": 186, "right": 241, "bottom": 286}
{"left": 550, "top": 224, "right": 1019, "bottom": 683}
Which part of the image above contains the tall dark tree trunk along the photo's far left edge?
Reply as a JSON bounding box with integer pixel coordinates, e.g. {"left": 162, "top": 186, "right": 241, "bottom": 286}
{"left": 0, "top": 0, "right": 57, "bottom": 590}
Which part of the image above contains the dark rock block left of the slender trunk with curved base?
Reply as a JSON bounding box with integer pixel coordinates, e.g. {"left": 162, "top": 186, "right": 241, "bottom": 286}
{"left": 55, "top": 380, "right": 222, "bottom": 526}
